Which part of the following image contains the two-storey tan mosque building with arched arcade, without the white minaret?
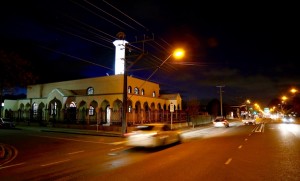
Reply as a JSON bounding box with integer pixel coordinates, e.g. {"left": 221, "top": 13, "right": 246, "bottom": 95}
{"left": 2, "top": 74, "right": 187, "bottom": 126}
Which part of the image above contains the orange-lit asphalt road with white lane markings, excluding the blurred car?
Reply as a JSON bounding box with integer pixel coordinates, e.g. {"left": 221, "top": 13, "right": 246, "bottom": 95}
{"left": 0, "top": 119, "right": 300, "bottom": 181}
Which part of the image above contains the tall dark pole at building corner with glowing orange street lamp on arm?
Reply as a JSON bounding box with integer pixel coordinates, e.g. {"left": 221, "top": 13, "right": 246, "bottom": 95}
{"left": 122, "top": 48, "right": 185, "bottom": 135}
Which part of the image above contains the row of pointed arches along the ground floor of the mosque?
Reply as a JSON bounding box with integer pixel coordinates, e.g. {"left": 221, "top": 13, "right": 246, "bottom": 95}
{"left": 5, "top": 98, "right": 186, "bottom": 125}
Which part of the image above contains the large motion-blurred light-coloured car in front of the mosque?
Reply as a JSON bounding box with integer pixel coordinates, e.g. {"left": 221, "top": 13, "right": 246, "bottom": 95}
{"left": 125, "top": 123, "right": 181, "bottom": 148}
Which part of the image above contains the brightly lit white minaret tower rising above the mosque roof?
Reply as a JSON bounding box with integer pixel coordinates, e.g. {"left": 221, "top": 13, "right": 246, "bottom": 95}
{"left": 113, "top": 32, "right": 128, "bottom": 75}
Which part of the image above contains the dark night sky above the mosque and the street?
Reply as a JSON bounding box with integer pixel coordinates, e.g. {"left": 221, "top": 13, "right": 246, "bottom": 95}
{"left": 0, "top": 0, "right": 300, "bottom": 105}
